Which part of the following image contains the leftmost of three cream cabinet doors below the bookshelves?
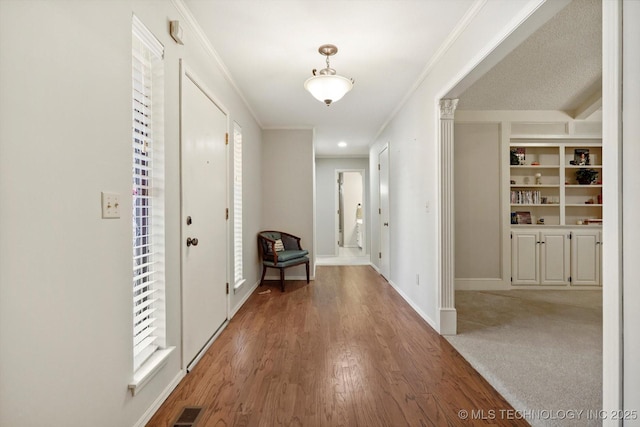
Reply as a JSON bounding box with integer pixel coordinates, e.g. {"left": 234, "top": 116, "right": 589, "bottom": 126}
{"left": 511, "top": 231, "right": 540, "bottom": 285}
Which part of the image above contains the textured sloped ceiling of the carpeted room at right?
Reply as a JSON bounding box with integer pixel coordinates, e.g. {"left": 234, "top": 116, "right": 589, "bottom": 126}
{"left": 458, "top": 0, "right": 602, "bottom": 116}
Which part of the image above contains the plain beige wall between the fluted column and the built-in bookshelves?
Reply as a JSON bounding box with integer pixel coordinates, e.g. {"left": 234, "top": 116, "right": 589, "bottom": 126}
{"left": 454, "top": 123, "right": 503, "bottom": 279}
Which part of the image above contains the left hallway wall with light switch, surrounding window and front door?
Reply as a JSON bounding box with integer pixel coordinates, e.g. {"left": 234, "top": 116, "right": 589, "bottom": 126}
{"left": 0, "top": 0, "right": 262, "bottom": 427}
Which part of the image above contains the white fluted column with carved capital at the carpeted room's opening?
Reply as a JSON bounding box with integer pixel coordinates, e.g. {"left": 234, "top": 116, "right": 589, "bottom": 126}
{"left": 438, "top": 99, "right": 458, "bottom": 335}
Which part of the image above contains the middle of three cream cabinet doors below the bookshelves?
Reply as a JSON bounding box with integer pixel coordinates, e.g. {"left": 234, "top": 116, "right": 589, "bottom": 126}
{"left": 540, "top": 231, "right": 570, "bottom": 285}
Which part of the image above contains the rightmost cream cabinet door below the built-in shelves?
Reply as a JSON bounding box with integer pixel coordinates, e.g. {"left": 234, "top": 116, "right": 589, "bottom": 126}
{"left": 571, "top": 230, "right": 600, "bottom": 286}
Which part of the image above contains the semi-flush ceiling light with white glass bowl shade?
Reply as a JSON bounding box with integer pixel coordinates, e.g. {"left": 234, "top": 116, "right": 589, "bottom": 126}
{"left": 304, "top": 44, "right": 353, "bottom": 107}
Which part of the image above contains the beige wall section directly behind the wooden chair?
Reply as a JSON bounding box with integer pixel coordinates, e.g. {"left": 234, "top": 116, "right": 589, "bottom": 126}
{"left": 262, "top": 130, "right": 315, "bottom": 279}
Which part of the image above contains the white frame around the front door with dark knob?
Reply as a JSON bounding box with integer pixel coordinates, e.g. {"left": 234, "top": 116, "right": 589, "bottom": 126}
{"left": 178, "top": 58, "right": 231, "bottom": 372}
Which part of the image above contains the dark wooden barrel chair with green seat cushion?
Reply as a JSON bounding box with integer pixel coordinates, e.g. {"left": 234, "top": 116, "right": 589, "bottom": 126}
{"left": 258, "top": 230, "right": 309, "bottom": 292}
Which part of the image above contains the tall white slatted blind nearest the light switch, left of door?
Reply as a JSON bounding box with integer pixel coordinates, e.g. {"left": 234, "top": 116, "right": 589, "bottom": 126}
{"left": 132, "top": 17, "right": 164, "bottom": 371}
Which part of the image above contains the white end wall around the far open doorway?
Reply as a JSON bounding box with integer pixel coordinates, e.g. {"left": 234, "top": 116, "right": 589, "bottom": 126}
{"left": 316, "top": 157, "right": 371, "bottom": 256}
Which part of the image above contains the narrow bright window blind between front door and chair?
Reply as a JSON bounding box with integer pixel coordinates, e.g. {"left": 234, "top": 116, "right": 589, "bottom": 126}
{"left": 233, "top": 123, "right": 243, "bottom": 285}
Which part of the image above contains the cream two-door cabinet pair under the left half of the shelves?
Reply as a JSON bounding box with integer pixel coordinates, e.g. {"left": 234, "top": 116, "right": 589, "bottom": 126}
{"left": 511, "top": 230, "right": 570, "bottom": 285}
